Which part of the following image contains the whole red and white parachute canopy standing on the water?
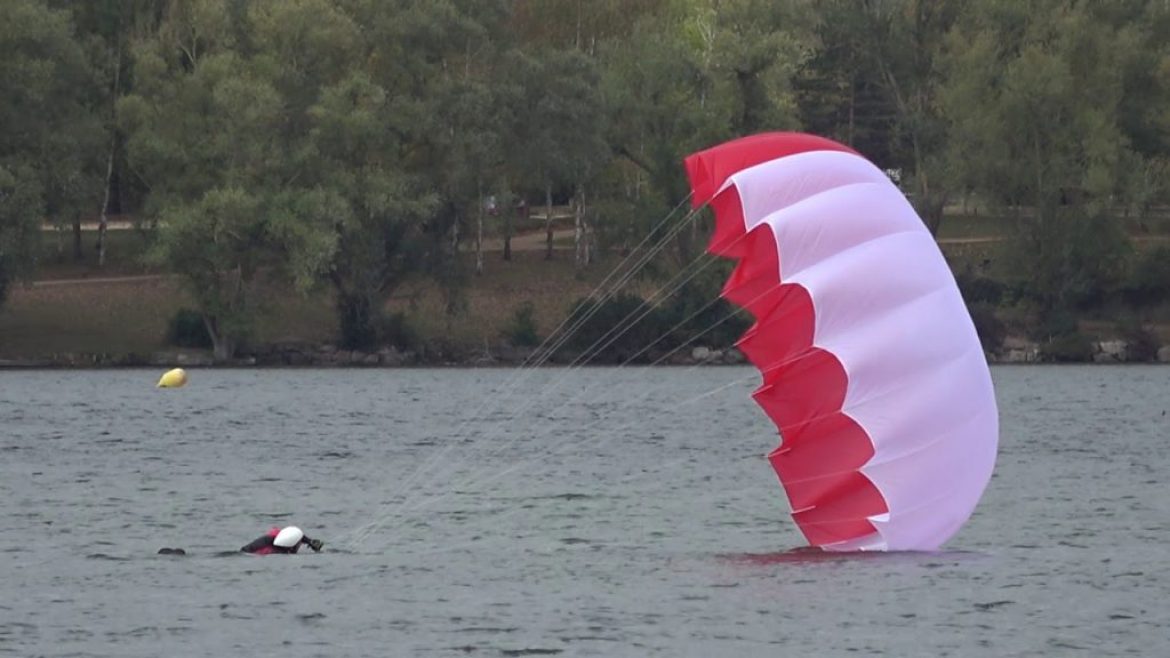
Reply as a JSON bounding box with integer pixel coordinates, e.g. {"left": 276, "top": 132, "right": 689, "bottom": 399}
{"left": 686, "top": 133, "right": 998, "bottom": 550}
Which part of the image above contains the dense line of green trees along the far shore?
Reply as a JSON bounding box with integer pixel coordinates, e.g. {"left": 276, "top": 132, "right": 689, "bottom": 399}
{"left": 0, "top": 0, "right": 1170, "bottom": 358}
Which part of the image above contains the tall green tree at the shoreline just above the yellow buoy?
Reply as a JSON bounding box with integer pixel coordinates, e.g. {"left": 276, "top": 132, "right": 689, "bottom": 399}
{"left": 118, "top": 0, "right": 293, "bottom": 359}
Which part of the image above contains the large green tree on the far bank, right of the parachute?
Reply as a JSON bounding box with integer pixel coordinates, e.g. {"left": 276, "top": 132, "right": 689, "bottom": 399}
{"left": 942, "top": 0, "right": 1148, "bottom": 310}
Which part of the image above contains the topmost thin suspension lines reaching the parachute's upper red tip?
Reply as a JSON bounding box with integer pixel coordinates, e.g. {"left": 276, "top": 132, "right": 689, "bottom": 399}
{"left": 341, "top": 193, "right": 698, "bottom": 545}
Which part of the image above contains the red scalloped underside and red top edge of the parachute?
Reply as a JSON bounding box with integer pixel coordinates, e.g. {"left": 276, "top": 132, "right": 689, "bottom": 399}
{"left": 686, "top": 132, "right": 888, "bottom": 546}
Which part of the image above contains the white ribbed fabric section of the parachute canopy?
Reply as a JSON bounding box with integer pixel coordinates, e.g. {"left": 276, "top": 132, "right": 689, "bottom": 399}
{"left": 729, "top": 151, "right": 998, "bottom": 550}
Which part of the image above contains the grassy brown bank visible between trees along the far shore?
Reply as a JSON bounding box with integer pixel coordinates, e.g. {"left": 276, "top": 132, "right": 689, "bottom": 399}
{"left": 0, "top": 214, "right": 1170, "bottom": 359}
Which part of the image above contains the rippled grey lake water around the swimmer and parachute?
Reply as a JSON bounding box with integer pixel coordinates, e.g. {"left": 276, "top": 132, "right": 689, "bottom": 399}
{"left": 0, "top": 366, "right": 1170, "bottom": 657}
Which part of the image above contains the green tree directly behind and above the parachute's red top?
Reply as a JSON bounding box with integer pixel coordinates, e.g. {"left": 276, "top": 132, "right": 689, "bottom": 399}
{"left": 599, "top": 0, "right": 806, "bottom": 263}
